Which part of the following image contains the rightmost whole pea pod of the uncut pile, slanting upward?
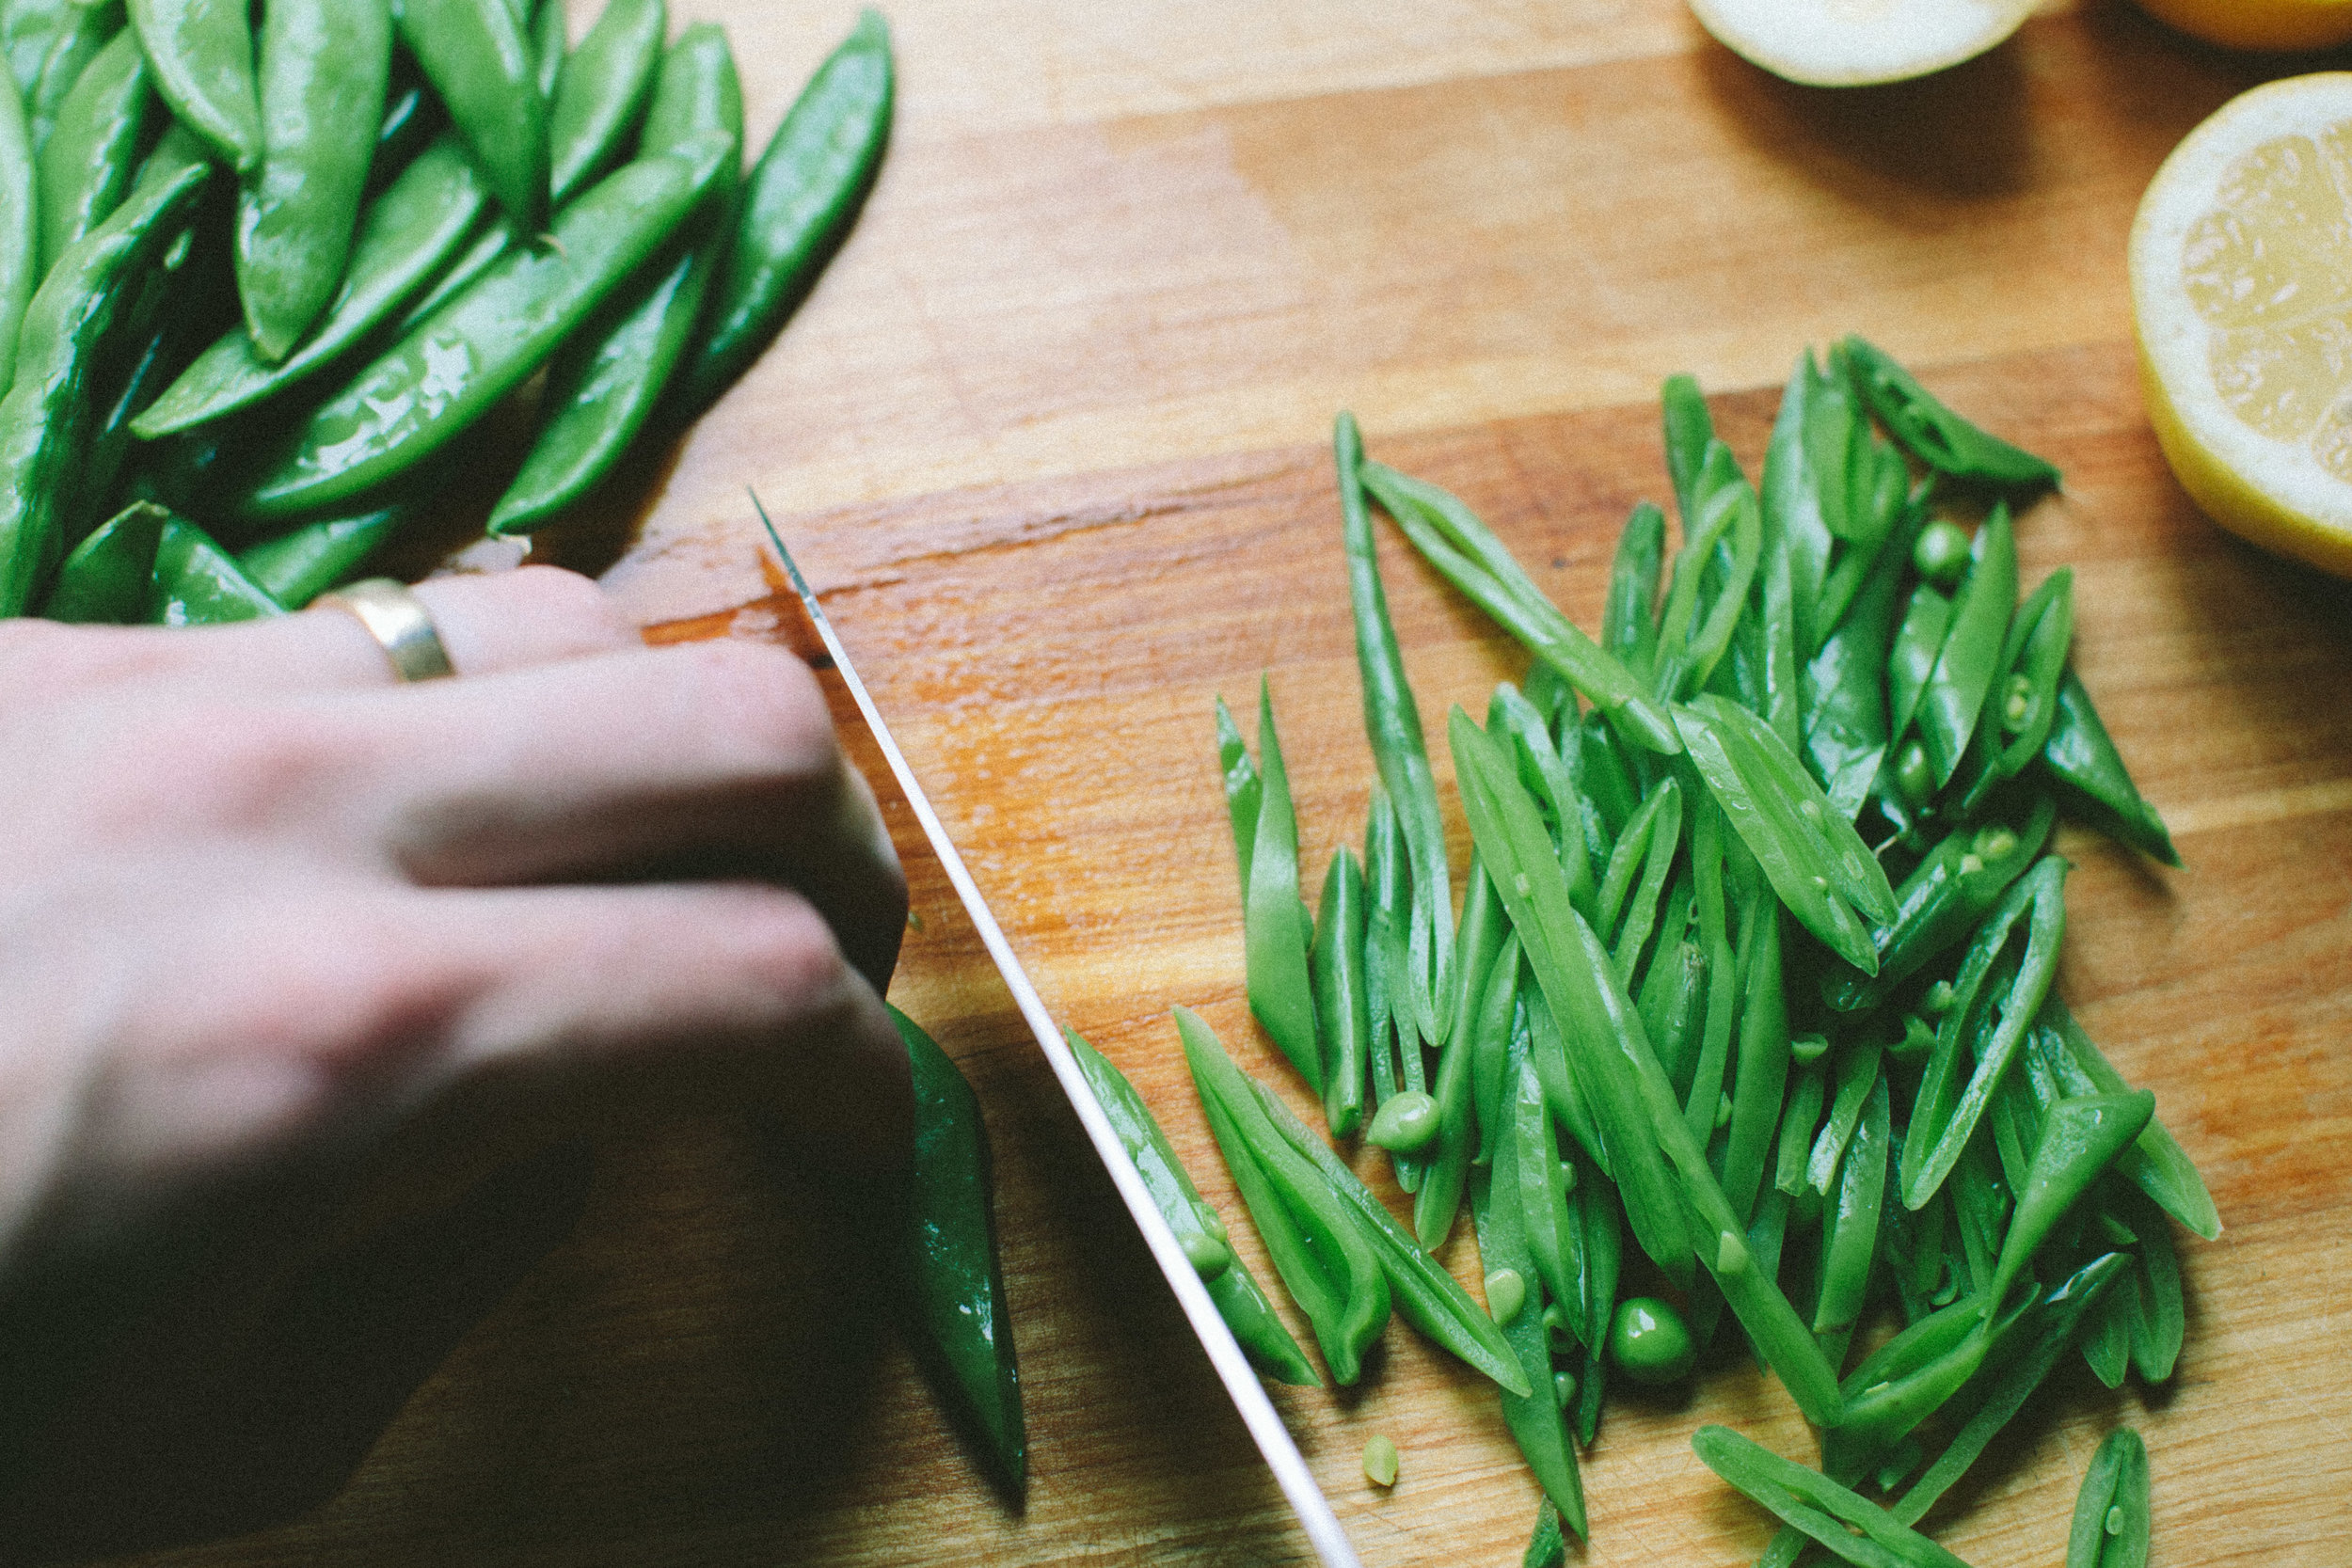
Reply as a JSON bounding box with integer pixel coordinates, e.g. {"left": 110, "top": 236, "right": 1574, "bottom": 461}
{"left": 675, "top": 9, "right": 894, "bottom": 425}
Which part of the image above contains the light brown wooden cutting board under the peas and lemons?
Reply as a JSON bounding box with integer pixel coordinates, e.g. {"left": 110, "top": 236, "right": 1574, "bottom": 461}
{"left": 114, "top": 0, "right": 2352, "bottom": 1568}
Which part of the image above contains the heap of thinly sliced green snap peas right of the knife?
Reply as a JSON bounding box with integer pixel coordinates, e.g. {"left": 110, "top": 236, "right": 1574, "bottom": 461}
{"left": 1080, "top": 339, "right": 2220, "bottom": 1568}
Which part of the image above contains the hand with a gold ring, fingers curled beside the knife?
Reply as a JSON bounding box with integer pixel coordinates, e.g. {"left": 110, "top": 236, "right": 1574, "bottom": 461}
{"left": 0, "top": 569, "right": 908, "bottom": 1549}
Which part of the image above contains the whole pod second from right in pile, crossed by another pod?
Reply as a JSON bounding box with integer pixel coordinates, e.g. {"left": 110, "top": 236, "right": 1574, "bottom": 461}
{"left": 489, "top": 11, "right": 734, "bottom": 535}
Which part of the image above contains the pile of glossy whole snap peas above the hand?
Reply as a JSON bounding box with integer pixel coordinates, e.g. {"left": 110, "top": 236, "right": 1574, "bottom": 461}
{"left": 0, "top": 0, "right": 894, "bottom": 623}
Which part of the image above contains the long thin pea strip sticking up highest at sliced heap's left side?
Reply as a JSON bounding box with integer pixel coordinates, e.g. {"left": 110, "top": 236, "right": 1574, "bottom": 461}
{"left": 1331, "top": 411, "right": 1456, "bottom": 1055}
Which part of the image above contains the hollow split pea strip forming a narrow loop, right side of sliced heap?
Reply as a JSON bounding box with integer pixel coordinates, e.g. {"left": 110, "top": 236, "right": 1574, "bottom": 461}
{"left": 1903, "top": 856, "right": 2068, "bottom": 1209}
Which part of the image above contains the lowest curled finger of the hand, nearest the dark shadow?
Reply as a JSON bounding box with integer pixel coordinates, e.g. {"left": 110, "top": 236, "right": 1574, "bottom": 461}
{"left": 69, "top": 881, "right": 913, "bottom": 1206}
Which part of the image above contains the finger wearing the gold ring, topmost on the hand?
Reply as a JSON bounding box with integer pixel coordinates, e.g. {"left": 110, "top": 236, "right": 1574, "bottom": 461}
{"left": 9, "top": 566, "right": 640, "bottom": 693}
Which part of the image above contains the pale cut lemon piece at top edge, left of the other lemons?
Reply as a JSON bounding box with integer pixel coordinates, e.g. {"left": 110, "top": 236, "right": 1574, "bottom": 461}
{"left": 1692, "top": 0, "right": 2035, "bottom": 87}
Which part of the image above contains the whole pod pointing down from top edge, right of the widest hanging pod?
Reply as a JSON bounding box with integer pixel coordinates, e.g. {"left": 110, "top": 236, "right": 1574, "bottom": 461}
{"left": 400, "top": 0, "right": 548, "bottom": 235}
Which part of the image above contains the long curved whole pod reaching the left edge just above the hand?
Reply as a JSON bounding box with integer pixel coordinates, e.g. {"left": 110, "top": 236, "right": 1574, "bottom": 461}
{"left": 0, "top": 145, "right": 210, "bottom": 616}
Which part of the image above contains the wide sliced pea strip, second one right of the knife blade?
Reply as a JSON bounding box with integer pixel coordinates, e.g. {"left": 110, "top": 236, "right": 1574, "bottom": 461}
{"left": 1176, "top": 1006, "right": 1392, "bottom": 1385}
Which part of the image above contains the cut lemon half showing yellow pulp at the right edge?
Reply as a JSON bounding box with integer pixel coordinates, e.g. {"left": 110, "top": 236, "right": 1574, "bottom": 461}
{"left": 2131, "top": 72, "right": 2352, "bottom": 576}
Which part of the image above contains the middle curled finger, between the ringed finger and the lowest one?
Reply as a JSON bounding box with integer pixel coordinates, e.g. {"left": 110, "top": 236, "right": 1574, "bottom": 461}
{"left": 351, "top": 641, "right": 906, "bottom": 990}
